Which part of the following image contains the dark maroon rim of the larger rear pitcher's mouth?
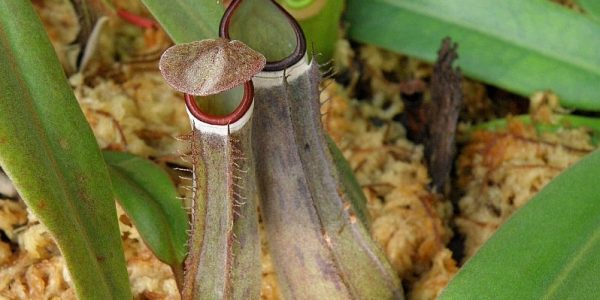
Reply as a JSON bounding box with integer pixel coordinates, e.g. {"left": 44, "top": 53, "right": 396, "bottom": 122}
{"left": 219, "top": 0, "right": 306, "bottom": 72}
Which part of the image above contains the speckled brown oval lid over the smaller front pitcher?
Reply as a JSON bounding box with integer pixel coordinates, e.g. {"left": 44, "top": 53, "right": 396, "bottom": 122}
{"left": 159, "top": 39, "right": 266, "bottom": 96}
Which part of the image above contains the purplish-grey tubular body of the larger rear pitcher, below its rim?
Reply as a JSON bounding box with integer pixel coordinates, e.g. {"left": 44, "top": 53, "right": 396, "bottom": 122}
{"left": 253, "top": 60, "right": 403, "bottom": 299}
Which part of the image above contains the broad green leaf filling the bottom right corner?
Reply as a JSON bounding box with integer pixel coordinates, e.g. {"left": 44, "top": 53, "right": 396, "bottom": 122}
{"left": 441, "top": 151, "right": 600, "bottom": 299}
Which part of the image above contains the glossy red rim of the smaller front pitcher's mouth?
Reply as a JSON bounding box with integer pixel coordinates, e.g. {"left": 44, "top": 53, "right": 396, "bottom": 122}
{"left": 184, "top": 80, "right": 254, "bottom": 125}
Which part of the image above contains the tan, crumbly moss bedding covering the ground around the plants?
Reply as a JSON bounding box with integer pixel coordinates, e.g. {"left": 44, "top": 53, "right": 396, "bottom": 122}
{"left": 0, "top": 0, "right": 595, "bottom": 299}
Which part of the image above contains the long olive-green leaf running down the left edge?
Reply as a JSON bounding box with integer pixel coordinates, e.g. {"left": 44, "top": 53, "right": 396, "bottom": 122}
{"left": 0, "top": 0, "right": 132, "bottom": 299}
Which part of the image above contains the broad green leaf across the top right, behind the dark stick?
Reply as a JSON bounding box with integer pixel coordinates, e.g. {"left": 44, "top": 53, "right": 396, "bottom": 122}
{"left": 346, "top": 0, "right": 600, "bottom": 111}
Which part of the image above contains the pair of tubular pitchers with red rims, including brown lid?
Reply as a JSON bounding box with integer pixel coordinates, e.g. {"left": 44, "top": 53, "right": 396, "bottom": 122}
{"left": 160, "top": 0, "right": 404, "bottom": 299}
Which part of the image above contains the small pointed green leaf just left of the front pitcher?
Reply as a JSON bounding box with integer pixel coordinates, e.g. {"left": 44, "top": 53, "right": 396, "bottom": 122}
{"left": 103, "top": 151, "right": 188, "bottom": 269}
